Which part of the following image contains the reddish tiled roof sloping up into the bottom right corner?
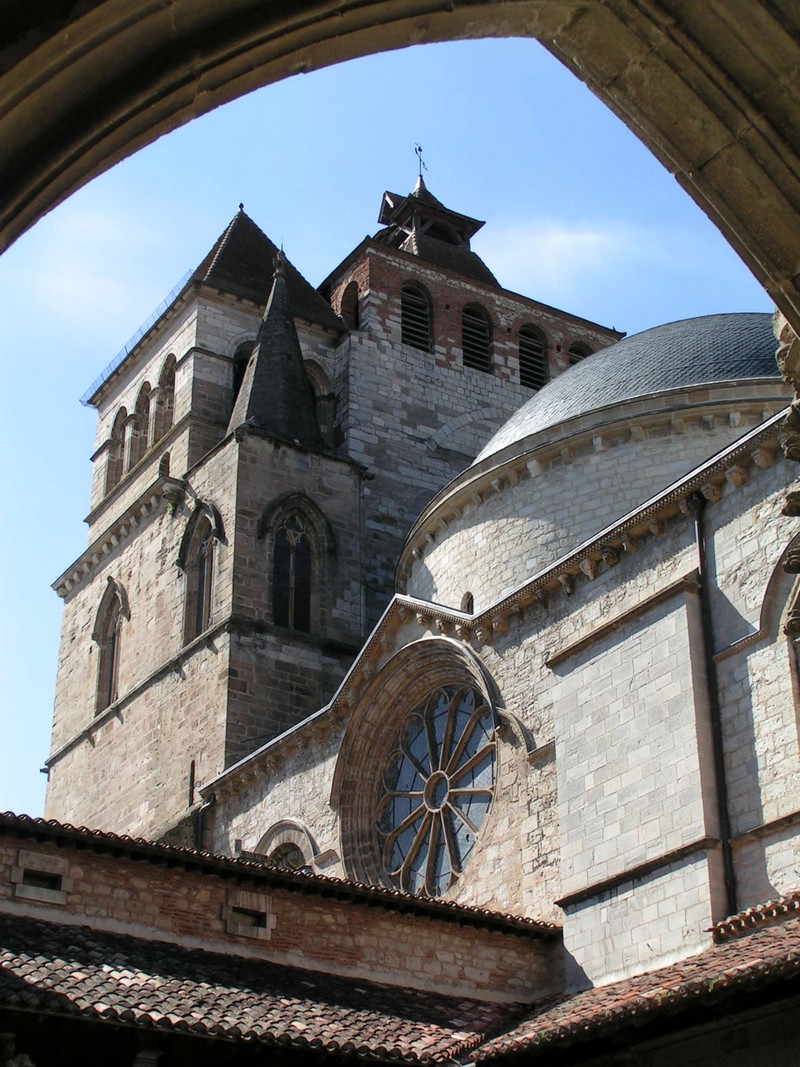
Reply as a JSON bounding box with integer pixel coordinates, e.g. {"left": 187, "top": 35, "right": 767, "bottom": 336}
{"left": 474, "top": 919, "right": 800, "bottom": 1061}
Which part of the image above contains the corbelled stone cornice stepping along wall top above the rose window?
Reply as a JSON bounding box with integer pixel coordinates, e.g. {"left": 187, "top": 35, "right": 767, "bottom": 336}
{"left": 199, "top": 411, "right": 785, "bottom": 798}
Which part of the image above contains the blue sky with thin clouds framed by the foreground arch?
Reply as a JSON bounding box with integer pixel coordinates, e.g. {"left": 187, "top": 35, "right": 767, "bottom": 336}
{"left": 0, "top": 33, "right": 772, "bottom": 815}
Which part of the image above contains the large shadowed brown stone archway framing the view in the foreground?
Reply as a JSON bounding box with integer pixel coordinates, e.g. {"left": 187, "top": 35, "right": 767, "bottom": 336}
{"left": 0, "top": 0, "right": 800, "bottom": 328}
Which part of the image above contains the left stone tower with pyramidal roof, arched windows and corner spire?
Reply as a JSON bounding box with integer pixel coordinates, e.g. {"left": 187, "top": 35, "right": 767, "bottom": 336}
{"left": 47, "top": 211, "right": 364, "bottom": 840}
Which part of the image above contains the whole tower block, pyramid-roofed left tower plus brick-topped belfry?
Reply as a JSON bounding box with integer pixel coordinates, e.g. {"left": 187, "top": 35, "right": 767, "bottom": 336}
{"left": 47, "top": 187, "right": 619, "bottom": 841}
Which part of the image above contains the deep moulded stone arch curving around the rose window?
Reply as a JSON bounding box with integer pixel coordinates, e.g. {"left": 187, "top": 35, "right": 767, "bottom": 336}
{"left": 331, "top": 637, "right": 501, "bottom": 885}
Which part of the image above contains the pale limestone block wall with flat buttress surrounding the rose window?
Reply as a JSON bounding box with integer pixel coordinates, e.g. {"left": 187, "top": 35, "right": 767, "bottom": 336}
{"left": 201, "top": 459, "right": 800, "bottom": 986}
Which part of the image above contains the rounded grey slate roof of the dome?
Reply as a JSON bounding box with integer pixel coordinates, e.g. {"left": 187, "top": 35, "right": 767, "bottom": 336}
{"left": 475, "top": 313, "right": 780, "bottom": 463}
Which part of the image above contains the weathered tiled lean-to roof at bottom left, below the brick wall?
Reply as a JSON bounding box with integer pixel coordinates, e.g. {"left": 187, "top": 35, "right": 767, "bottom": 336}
{"left": 0, "top": 914, "right": 519, "bottom": 1062}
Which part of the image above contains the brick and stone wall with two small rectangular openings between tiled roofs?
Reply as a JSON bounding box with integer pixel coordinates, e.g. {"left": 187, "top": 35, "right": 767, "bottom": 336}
{"left": 0, "top": 835, "right": 561, "bottom": 1002}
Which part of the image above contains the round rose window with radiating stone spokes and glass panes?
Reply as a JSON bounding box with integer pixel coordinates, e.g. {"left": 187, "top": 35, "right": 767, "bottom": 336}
{"left": 378, "top": 686, "right": 496, "bottom": 896}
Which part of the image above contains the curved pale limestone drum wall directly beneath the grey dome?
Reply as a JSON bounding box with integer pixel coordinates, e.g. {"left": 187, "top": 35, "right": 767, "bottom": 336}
{"left": 406, "top": 403, "right": 785, "bottom": 611}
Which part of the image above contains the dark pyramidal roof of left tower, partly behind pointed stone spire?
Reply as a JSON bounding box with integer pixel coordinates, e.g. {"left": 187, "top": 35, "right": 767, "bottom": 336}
{"left": 196, "top": 210, "right": 343, "bottom": 332}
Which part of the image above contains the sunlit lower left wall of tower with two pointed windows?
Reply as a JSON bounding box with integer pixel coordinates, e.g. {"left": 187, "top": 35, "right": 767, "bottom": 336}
{"left": 47, "top": 448, "right": 237, "bottom": 833}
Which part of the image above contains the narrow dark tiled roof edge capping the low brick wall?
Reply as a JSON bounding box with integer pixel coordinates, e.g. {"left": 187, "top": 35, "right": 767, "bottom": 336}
{"left": 0, "top": 811, "right": 561, "bottom": 939}
